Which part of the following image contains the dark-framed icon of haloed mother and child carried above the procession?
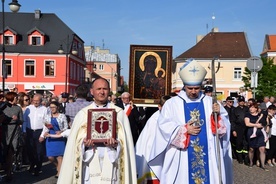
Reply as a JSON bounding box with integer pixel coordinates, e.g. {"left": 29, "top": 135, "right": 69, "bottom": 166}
{"left": 129, "top": 45, "right": 172, "bottom": 104}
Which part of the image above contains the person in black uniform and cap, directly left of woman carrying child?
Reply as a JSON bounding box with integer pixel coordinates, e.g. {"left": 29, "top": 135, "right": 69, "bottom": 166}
{"left": 232, "top": 96, "right": 249, "bottom": 165}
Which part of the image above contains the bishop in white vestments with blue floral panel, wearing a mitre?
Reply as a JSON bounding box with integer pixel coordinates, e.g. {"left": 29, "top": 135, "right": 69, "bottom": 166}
{"left": 149, "top": 60, "right": 233, "bottom": 184}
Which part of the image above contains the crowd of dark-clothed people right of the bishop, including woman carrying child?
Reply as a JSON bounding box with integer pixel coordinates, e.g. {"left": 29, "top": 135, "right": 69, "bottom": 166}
{"left": 224, "top": 96, "right": 276, "bottom": 171}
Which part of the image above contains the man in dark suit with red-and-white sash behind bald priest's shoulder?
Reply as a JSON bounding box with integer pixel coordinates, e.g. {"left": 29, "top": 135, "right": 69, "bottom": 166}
{"left": 116, "top": 92, "right": 140, "bottom": 145}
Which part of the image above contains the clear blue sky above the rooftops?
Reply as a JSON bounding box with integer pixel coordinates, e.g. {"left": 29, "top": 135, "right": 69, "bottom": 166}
{"left": 10, "top": 0, "right": 276, "bottom": 82}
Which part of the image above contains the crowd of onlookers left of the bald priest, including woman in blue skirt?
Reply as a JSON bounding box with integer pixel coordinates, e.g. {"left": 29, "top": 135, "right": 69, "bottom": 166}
{"left": 0, "top": 85, "right": 94, "bottom": 182}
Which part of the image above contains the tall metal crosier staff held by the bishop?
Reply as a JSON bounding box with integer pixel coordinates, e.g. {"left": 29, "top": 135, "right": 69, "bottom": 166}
{"left": 211, "top": 58, "right": 222, "bottom": 184}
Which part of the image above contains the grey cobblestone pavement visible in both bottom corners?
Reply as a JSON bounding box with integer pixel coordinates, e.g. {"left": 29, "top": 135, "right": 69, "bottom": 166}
{"left": 0, "top": 160, "right": 276, "bottom": 184}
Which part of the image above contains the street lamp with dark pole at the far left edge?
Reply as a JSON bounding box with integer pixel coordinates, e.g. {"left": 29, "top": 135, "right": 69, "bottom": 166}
{"left": 2, "top": 0, "right": 21, "bottom": 94}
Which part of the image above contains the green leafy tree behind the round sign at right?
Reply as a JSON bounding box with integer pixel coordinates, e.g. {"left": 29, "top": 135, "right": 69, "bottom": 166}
{"left": 242, "top": 58, "right": 276, "bottom": 99}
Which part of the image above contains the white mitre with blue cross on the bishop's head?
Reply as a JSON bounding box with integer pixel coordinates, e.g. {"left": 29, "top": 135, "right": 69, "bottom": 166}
{"left": 178, "top": 59, "right": 207, "bottom": 86}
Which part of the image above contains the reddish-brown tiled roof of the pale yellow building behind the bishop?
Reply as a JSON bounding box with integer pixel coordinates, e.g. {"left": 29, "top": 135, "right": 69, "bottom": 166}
{"left": 176, "top": 32, "right": 251, "bottom": 60}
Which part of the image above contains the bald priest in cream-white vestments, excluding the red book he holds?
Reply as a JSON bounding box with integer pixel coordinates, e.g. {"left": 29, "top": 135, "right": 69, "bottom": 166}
{"left": 58, "top": 78, "right": 137, "bottom": 184}
